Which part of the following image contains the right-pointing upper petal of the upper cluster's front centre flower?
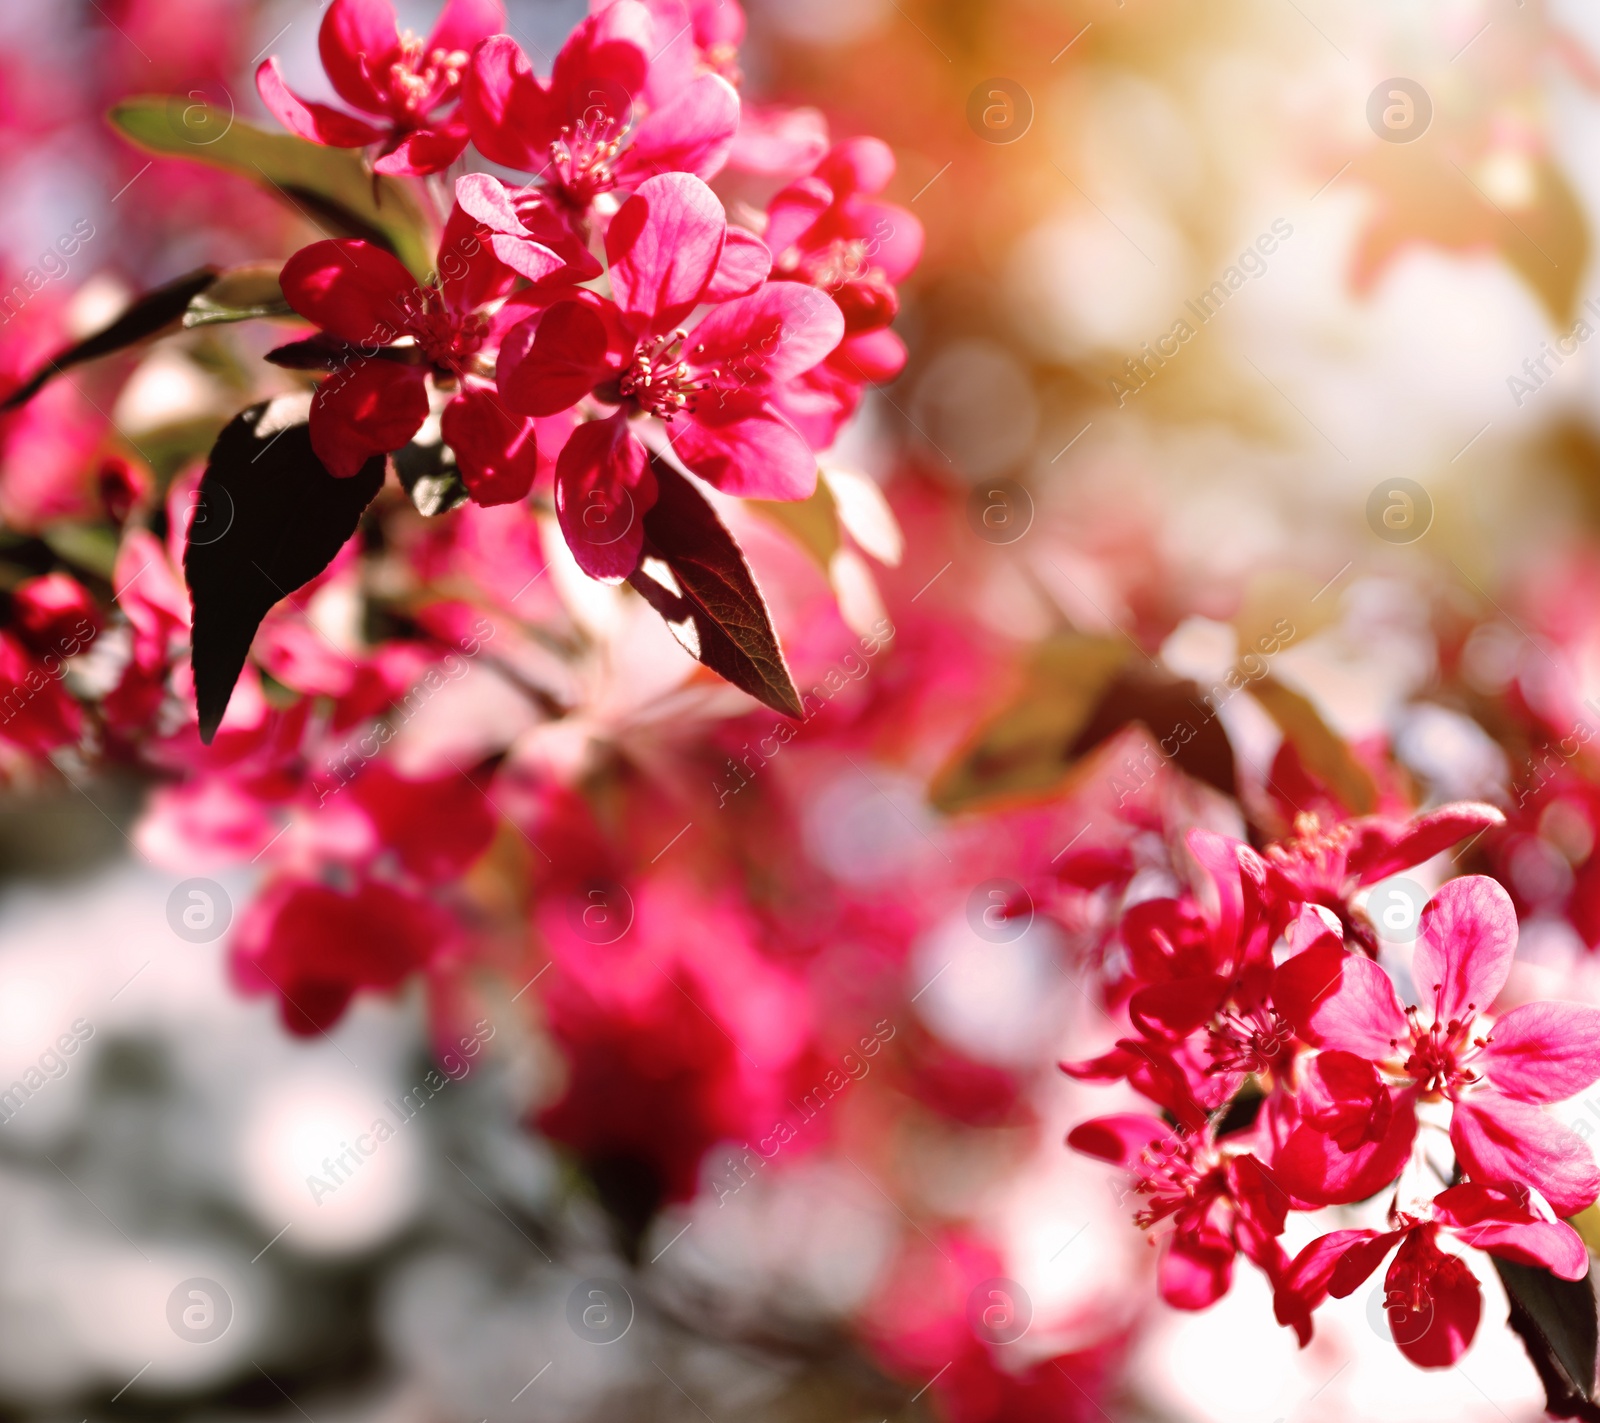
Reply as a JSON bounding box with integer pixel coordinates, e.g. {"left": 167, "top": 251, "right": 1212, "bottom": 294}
{"left": 688, "top": 282, "right": 845, "bottom": 389}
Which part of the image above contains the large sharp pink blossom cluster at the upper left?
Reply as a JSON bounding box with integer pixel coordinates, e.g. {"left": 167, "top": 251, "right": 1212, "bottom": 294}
{"left": 256, "top": 0, "right": 922, "bottom": 578}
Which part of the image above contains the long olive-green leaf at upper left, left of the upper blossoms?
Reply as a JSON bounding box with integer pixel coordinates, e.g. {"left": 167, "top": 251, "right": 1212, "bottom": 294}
{"left": 109, "top": 94, "right": 434, "bottom": 279}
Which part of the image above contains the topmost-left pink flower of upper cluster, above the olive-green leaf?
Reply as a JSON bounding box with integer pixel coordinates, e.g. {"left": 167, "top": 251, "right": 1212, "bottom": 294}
{"left": 256, "top": 0, "right": 506, "bottom": 174}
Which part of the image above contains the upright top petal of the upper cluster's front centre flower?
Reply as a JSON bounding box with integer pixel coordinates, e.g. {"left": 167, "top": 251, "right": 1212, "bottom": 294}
{"left": 605, "top": 172, "right": 728, "bottom": 331}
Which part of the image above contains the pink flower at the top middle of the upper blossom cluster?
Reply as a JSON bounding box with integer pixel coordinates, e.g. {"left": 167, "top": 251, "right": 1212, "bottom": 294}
{"left": 462, "top": 0, "right": 739, "bottom": 216}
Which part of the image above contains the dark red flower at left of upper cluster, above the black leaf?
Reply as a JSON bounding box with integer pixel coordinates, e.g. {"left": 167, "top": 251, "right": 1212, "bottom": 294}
{"left": 274, "top": 173, "right": 589, "bottom": 489}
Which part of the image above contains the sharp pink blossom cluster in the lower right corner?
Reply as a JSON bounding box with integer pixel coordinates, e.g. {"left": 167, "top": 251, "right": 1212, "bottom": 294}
{"left": 1062, "top": 804, "right": 1600, "bottom": 1367}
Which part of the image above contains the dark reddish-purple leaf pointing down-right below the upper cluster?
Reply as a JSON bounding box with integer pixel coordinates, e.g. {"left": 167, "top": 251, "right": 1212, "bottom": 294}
{"left": 627, "top": 455, "right": 805, "bottom": 719}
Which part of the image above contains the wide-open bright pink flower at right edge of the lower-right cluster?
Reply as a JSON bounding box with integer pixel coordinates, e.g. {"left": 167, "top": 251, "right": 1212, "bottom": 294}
{"left": 1274, "top": 876, "right": 1600, "bottom": 1217}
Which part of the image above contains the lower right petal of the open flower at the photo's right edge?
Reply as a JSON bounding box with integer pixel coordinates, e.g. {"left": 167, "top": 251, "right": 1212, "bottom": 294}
{"left": 1450, "top": 1092, "right": 1600, "bottom": 1217}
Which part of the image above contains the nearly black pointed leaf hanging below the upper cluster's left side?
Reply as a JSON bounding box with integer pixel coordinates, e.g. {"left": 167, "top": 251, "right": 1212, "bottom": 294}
{"left": 184, "top": 395, "right": 386, "bottom": 743}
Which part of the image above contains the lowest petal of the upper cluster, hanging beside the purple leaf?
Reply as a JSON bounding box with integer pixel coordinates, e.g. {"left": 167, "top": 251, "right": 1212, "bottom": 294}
{"left": 555, "top": 413, "right": 656, "bottom": 581}
